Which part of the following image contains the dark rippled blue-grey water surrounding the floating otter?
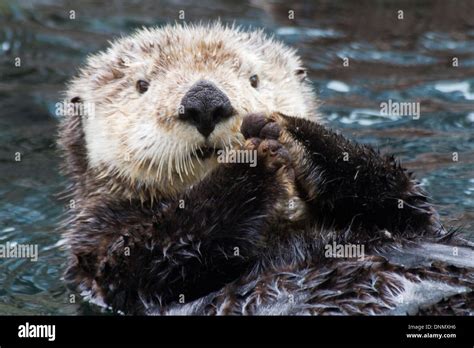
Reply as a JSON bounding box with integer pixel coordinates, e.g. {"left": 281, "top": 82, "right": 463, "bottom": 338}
{"left": 0, "top": 0, "right": 474, "bottom": 314}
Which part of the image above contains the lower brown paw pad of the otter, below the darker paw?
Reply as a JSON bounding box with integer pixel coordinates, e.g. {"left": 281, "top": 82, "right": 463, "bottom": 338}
{"left": 245, "top": 138, "right": 291, "bottom": 172}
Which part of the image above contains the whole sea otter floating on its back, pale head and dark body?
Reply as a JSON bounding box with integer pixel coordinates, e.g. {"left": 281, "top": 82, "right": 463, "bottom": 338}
{"left": 59, "top": 23, "right": 474, "bottom": 314}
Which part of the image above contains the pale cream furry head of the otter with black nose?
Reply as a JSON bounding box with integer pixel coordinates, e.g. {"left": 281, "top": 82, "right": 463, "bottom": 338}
{"left": 68, "top": 24, "right": 316, "bottom": 198}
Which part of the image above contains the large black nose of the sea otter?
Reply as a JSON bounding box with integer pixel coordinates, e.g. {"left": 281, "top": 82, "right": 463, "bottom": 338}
{"left": 180, "top": 80, "right": 234, "bottom": 138}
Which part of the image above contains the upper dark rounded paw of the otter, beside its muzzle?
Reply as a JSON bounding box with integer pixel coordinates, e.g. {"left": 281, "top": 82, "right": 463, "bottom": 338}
{"left": 240, "top": 113, "right": 281, "bottom": 139}
